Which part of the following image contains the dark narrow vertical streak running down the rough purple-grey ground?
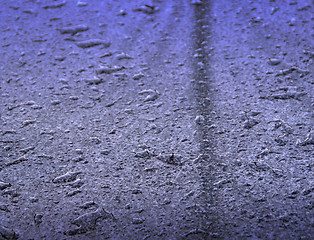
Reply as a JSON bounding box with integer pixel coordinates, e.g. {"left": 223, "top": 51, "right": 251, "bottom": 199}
{"left": 192, "top": 1, "right": 217, "bottom": 234}
